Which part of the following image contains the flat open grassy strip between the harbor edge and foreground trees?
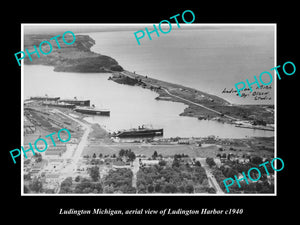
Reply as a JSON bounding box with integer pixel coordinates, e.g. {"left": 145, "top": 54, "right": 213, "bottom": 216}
{"left": 82, "top": 138, "right": 274, "bottom": 158}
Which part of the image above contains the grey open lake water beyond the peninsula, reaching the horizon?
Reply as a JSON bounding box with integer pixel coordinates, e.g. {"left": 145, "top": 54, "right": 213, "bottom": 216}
{"left": 88, "top": 25, "right": 275, "bottom": 104}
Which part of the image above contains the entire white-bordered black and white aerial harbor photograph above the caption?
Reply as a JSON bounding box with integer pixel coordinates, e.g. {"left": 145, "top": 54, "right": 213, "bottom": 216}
{"left": 20, "top": 22, "right": 276, "bottom": 195}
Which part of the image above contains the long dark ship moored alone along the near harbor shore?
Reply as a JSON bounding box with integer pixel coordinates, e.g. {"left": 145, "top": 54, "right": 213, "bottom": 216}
{"left": 112, "top": 125, "right": 164, "bottom": 138}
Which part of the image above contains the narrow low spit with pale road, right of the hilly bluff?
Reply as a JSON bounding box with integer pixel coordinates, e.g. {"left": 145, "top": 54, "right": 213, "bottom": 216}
{"left": 108, "top": 70, "right": 274, "bottom": 131}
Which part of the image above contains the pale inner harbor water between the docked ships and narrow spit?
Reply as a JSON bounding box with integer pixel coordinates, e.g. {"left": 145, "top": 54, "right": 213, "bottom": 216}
{"left": 24, "top": 65, "right": 274, "bottom": 138}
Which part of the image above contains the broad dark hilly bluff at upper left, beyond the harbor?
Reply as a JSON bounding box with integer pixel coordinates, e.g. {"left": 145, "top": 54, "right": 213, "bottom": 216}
{"left": 24, "top": 34, "right": 123, "bottom": 73}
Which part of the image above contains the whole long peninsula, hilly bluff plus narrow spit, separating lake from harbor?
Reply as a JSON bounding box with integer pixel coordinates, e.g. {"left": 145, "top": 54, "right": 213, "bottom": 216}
{"left": 24, "top": 34, "right": 274, "bottom": 130}
